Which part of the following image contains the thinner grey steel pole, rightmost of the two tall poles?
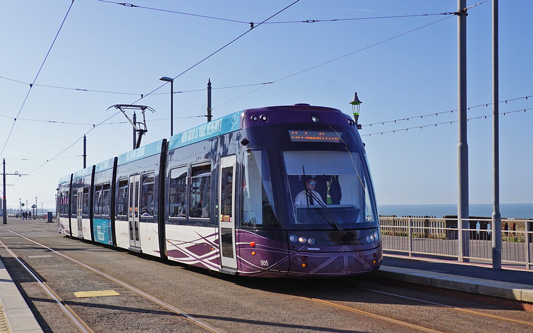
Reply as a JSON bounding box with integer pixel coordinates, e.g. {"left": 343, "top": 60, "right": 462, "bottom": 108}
{"left": 492, "top": 0, "right": 502, "bottom": 269}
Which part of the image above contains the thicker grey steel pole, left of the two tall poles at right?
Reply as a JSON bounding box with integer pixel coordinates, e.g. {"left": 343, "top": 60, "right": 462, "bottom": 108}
{"left": 456, "top": 0, "right": 469, "bottom": 261}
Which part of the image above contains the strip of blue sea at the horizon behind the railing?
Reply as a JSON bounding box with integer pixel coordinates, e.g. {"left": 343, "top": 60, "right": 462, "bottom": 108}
{"left": 378, "top": 203, "right": 533, "bottom": 219}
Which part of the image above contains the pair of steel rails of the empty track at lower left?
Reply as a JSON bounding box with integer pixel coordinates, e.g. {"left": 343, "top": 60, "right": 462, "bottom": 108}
{"left": 0, "top": 229, "right": 219, "bottom": 333}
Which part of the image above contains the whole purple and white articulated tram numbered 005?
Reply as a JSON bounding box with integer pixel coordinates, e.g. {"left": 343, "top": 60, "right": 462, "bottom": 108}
{"left": 57, "top": 104, "right": 383, "bottom": 277}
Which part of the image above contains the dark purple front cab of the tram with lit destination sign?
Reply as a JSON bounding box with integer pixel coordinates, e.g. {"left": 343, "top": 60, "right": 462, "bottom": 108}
{"left": 235, "top": 105, "right": 382, "bottom": 276}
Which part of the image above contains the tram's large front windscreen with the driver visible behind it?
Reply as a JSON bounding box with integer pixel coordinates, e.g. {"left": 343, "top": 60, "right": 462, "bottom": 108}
{"left": 284, "top": 151, "right": 378, "bottom": 230}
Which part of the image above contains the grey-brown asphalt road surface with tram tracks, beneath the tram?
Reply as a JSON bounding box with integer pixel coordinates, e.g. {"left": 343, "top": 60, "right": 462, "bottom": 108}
{"left": 0, "top": 220, "right": 533, "bottom": 332}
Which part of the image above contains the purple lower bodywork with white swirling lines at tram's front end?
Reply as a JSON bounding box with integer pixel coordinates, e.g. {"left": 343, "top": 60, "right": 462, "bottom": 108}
{"left": 167, "top": 230, "right": 383, "bottom": 277}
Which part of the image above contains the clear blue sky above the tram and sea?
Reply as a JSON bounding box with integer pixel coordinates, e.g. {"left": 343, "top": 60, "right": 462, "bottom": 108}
{"left": 0, "top": 0, "right": 533, "bottom": 207}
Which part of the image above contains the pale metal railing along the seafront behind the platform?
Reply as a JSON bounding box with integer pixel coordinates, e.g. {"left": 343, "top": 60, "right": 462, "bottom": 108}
{"left": 380, "top": 216, "right": 533, "bottom": 269}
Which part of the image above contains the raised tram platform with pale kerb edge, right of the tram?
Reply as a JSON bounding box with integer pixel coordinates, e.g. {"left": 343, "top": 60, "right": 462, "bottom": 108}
{"left": 373, "top": 254, "right": 533, "bottom": 304}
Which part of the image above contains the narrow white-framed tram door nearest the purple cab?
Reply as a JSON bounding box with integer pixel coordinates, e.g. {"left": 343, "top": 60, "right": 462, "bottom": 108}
{"left": 218, "top": 155, "right": 237, "bottom": 269}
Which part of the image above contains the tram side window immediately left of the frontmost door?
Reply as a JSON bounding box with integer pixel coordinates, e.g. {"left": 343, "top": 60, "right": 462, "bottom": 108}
{"left": 189, "top": 164, "right": 211, "bottom": 218}
